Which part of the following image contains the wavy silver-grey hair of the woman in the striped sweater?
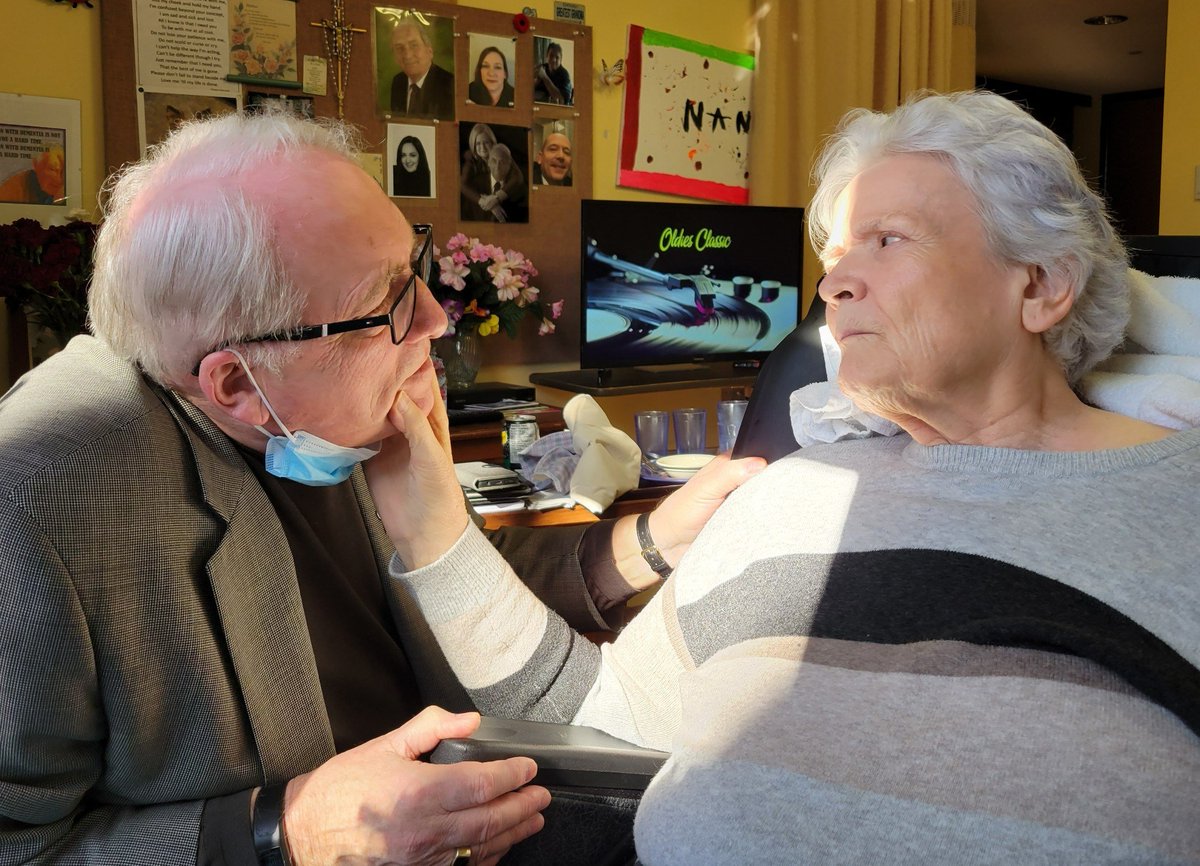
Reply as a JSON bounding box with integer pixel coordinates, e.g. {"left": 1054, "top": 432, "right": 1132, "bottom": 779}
{"left": 809, "top": 91, "right": 1129, "bottom": 384}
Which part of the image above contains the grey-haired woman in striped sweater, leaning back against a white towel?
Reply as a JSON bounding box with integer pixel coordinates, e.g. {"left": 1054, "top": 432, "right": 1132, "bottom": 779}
{"left": 367, "top": 92, "right": 1200, "bottom": 866}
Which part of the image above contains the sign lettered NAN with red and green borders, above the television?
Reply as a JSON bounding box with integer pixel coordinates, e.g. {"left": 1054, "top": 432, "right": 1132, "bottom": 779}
{"left": 617, "top": 25, "right": 754, "bottom": 204}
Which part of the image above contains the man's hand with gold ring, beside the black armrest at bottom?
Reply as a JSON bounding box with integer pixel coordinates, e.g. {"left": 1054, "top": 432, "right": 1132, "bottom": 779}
{"left": 283, "top": 706, "right": 550, "bottom": 866}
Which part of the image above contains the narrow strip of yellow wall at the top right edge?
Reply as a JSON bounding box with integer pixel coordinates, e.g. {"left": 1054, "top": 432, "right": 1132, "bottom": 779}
{"left": 1158, "top": 0, "right": 1200, "bottom": 235}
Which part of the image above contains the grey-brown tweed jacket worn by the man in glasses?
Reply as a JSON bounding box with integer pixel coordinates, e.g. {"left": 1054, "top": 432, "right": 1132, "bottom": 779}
{"left": 0, "top": 337, "right": 604, "bottom": 865}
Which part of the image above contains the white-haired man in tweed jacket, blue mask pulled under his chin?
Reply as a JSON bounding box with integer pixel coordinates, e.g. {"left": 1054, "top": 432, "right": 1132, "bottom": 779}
{"left": 0, "top": 114, "right": 754, "bottom": 866}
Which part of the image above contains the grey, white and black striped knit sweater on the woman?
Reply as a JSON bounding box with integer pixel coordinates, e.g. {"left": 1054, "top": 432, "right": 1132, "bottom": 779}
{"left": 394, "top": 431, "right": 1200, "bottom": 866}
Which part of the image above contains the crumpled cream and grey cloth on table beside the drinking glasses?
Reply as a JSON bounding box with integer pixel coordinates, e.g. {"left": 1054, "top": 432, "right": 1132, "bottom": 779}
{"left": 517, "top": 393, "right": 642, "bottom": 515}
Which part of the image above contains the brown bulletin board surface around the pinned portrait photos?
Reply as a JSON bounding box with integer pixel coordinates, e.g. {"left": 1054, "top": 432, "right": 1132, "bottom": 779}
{"left": 98, "top": 0, "right": 593, "bottom": 365}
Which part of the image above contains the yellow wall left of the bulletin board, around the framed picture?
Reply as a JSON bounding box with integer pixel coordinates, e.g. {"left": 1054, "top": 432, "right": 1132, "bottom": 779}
{"left": 0, "top": 0, "right": 105, "bottom": 383}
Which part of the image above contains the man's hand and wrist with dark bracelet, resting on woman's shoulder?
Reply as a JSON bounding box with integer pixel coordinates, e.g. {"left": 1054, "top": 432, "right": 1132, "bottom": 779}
{"left": 612, "top": 455, "right": 767, "bottom": 589}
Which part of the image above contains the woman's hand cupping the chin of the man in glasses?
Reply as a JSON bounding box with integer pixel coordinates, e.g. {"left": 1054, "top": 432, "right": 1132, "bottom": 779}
{"left": 364, "top": 392, "right": 467, "bottom": 571}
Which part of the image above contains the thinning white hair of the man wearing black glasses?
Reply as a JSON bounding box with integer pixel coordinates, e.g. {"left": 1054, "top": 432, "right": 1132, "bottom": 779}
{"left": 88, "top": 112, "right": 358, "bottom": 386}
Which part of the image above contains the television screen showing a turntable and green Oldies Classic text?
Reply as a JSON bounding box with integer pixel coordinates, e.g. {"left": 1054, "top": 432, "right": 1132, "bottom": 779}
{"left": 580, "top": 200, "right": 804, "bottom": 368}
